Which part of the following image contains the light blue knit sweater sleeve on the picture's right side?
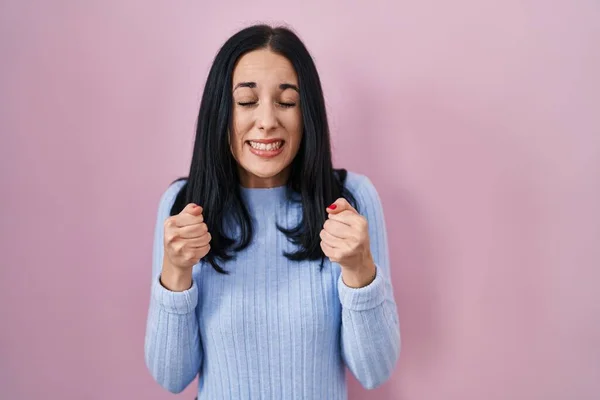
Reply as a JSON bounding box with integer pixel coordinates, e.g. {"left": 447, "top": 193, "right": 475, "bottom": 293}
{"left": 338, "top": 176, "right": 400, "bottom": 389}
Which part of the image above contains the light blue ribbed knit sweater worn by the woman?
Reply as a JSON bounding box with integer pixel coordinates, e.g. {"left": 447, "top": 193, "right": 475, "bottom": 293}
{"left": 145, "top": 173, "right": 400, "bottom": 400}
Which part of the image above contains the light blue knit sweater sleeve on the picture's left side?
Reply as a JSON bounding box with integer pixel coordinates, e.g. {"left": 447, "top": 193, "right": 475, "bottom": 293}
{"left": 144, "top": 181, "right": 202, "bottom": 393}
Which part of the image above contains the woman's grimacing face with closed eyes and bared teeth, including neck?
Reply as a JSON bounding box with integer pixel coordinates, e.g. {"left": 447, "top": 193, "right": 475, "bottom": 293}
{"left": 230, "top": 49, "right": 302, "bottom": 188}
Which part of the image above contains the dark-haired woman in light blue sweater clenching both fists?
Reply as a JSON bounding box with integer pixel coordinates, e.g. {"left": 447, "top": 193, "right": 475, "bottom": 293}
{"left": 145, "top": 25, "right": 400, "bottom": 400}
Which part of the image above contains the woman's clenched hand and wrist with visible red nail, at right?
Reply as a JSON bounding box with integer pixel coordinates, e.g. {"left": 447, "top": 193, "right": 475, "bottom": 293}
{"left": 319, "top": 198, "right": 375, "bottom": 287}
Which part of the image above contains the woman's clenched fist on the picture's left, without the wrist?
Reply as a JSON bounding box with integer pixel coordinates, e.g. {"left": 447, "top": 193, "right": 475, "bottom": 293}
{"left": 164, "top": 203, "right": 211, "bottom": 269}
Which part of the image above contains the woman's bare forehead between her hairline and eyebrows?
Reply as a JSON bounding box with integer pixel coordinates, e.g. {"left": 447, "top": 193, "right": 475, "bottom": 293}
{"left": 233, "top": 49, "right": 298, "bottom": 86}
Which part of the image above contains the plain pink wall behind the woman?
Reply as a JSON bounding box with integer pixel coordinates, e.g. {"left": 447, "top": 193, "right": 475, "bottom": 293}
{"left": 0, "top": 0, "right": 600, "bottom": 400}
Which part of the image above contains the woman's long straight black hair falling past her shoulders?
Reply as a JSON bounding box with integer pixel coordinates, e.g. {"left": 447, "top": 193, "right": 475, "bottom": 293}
{"left": 171, "top": 25, "right": 357, "bottom": 273}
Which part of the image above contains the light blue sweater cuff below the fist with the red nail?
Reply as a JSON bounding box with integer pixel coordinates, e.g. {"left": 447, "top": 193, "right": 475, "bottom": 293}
{"left": 338, "top": 266, "right": 385, "bottom": 311}
